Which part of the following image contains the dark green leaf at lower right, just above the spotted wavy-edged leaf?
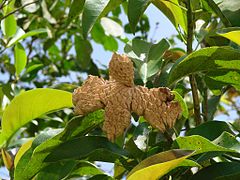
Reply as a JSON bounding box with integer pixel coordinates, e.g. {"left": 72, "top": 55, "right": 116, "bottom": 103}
{"left": 187, "top": 121, "right": 234, "bottom": 141}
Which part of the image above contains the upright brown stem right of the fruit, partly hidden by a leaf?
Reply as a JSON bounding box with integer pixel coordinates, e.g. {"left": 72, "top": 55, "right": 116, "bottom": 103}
{"left": 186, "top": 0, "right": 201, "bottom": 125}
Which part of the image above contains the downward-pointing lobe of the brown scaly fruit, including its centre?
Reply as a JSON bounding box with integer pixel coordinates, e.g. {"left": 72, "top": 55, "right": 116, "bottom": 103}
{"left": 103, "top": 81, "right": 133, "bottom": 141}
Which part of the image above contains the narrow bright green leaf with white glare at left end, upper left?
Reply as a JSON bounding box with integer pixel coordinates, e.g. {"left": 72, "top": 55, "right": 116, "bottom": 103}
{"left": 7, "top": 28, "right": 47, "bottom": 47}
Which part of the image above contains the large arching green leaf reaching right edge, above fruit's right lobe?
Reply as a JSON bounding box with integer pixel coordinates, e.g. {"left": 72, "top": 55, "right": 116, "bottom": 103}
{"left": 168, "top": 47, "right": 240, "bottom": 85}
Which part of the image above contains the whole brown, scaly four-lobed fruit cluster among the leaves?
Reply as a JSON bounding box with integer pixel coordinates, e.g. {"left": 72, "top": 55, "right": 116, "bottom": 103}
{"left": 73, "top": 54, "right": 181, "bottom": 140}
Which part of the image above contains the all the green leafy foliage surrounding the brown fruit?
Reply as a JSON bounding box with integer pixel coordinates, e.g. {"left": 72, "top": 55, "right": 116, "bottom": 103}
{"left": 0, "top": 0, "right": 240, "bottom": 180}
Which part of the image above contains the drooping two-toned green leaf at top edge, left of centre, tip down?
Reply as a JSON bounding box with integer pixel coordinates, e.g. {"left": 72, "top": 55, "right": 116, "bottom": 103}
{"left": 82, "top": 0, "right": 123, "bottom": 38}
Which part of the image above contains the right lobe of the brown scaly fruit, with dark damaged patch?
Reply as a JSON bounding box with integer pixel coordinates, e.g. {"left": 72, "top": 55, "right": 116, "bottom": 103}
{"left": 132, "top": 86, "right": 181, "bottom": 132}
